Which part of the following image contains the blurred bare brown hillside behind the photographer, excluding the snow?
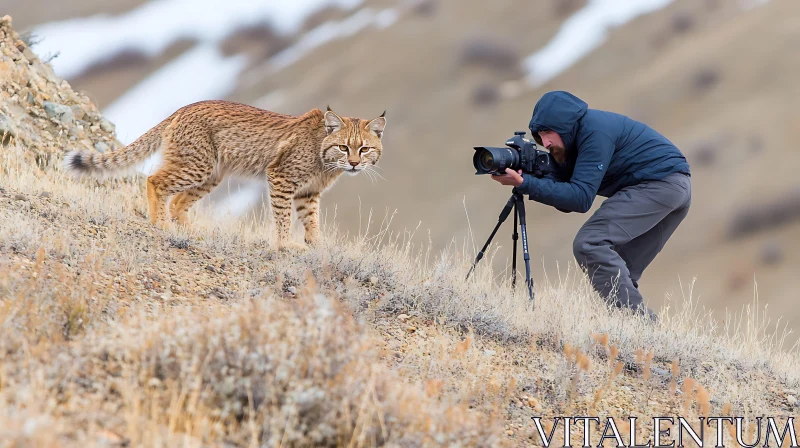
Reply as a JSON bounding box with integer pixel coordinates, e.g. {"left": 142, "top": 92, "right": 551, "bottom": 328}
{"left": 223, "top": 0, "right": 800, "bottom": 343}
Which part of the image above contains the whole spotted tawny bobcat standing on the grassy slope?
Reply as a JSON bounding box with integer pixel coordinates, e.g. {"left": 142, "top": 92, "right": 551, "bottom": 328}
{"left": 64, "top": 101, "right": 386, "bottom": 248}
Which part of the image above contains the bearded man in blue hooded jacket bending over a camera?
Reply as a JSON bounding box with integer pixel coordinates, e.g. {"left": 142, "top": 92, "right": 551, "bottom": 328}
{"left": 492, "top": 91, "right": 691, "bottom": 320}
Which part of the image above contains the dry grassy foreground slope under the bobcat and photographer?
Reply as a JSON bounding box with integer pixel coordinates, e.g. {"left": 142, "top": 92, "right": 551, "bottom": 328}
{"left": 0, "top": 14, "right": 800, "bottom": 447}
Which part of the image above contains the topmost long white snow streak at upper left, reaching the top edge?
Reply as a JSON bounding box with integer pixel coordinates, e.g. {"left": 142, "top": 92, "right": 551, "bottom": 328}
{"left": 33, "top": 0, "right": 363, "bottom": 78}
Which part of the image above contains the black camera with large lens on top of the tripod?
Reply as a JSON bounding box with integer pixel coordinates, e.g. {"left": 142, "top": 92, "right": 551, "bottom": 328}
{"left": 472, "top": 131, "right": 552, "bottom": 177}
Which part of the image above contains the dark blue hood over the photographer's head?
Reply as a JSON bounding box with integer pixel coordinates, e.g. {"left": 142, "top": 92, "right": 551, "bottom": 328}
{"left": 528, "top": 91, "right": 589, "bottom": 151}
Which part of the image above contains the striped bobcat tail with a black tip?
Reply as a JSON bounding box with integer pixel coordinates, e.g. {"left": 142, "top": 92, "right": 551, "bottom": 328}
{"left": 62, "top": 120, "right": 169, "bottom": 177}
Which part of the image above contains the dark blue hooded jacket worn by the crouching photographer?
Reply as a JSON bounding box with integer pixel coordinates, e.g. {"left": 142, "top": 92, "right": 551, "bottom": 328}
{"left": 518, "top": 91, "right": 690, "bottom": 213}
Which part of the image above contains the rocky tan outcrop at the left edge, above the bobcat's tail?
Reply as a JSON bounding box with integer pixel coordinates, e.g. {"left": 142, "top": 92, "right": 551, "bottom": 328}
{"left": 0, "top": 16, "right": 122, "bottom": 166}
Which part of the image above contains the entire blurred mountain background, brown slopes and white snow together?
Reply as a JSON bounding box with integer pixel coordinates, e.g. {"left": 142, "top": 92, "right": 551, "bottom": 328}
{"left": 6, "top": 0, "right": 800, "bottom": 342}
